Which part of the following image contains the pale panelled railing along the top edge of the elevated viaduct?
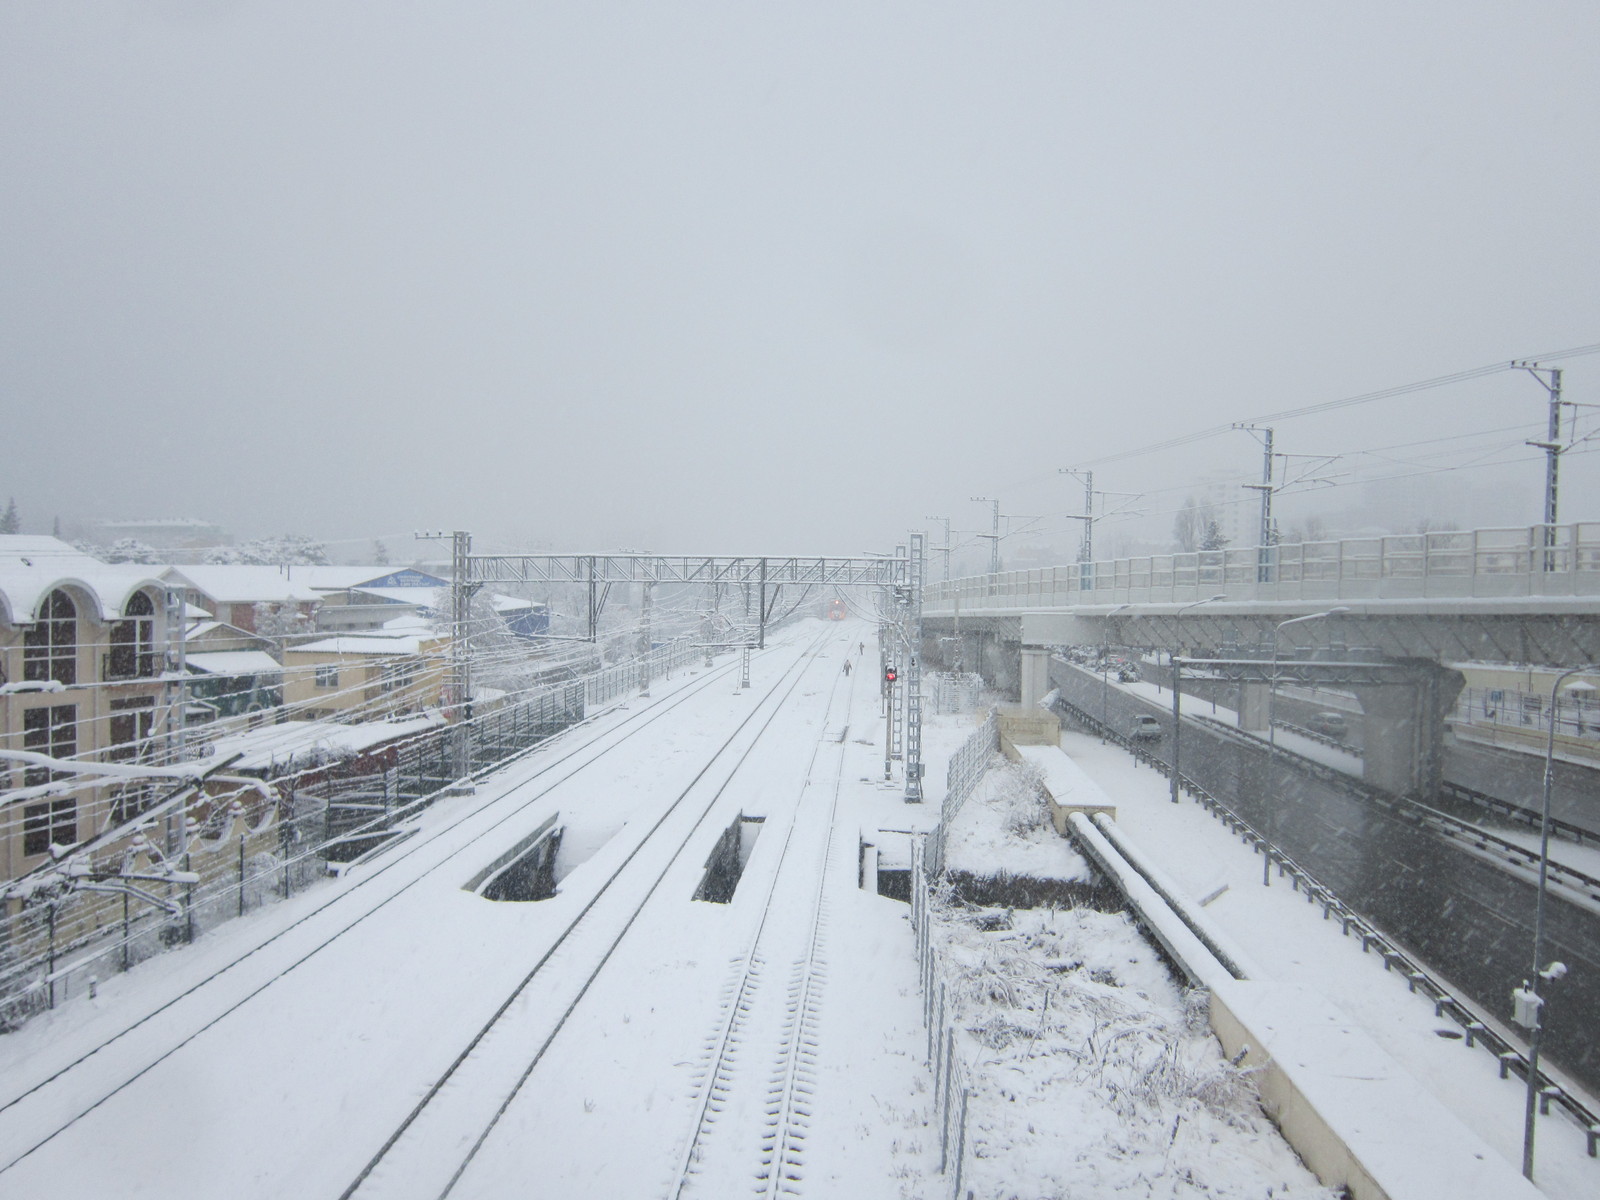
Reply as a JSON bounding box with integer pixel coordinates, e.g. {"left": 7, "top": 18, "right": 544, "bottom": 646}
{"left": 923, "top": 522, "right": 1600, "bottom": 614}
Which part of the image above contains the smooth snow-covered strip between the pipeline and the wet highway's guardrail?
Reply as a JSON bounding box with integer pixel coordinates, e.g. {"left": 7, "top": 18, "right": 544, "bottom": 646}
{"left": 1035, "top": 731, "right": 1600, "bottom": 1200}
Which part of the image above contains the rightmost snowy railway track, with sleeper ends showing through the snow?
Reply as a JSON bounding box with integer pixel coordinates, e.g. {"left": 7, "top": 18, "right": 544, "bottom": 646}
{"left": 670, "top": 662, "right": 854, "bottom": 1200}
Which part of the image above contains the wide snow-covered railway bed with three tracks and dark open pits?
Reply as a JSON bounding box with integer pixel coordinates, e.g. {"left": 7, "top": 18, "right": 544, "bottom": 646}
{"left": 0, "top": 626, "right": 925, "bottom": 1197}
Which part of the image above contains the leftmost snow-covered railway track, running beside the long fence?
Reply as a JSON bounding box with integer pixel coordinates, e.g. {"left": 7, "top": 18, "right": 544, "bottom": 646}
{"left": 0, "top": 649, "right": 768, "bottom": 1178}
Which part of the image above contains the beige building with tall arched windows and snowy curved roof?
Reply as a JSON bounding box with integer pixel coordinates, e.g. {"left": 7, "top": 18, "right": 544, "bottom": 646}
{"left": 0, "top": 536, "right": 176, "bottom": 880}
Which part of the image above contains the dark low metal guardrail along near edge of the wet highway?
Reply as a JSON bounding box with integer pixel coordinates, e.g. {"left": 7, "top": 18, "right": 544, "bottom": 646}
{"left": 1058, "top": 699, "right": 1600, "bottom": 1158}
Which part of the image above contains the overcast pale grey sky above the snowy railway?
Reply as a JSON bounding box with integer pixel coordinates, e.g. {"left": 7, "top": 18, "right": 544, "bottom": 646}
{"left": 0, "top": 0, "right": 1600, "bottom": 552}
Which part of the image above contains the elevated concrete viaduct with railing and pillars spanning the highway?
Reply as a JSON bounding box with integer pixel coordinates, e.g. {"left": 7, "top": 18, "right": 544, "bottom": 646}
{"left": 922, "top": 522, "right": 1600, "bottom": 795}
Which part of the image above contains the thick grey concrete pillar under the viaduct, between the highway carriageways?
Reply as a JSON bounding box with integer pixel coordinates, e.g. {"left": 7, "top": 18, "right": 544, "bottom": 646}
{"left": 1352, "top": 659, "right": 1466, "bottom": 797}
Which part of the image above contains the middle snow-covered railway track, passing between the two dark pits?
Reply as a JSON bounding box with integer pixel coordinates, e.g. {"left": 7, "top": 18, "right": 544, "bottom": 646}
{"left": 341, "top": 635, "right": 827, "bottom": 1200}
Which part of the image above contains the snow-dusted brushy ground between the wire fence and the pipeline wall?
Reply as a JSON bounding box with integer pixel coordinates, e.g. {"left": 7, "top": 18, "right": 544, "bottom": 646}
{"left": 931, "top": 764, "right": 1333, "bottom": 1200}
